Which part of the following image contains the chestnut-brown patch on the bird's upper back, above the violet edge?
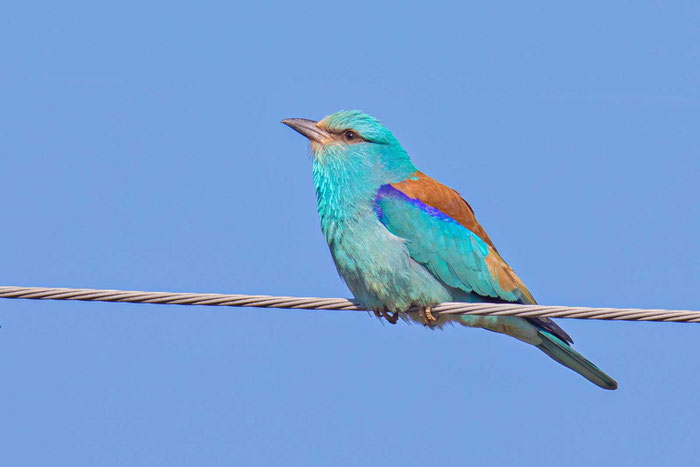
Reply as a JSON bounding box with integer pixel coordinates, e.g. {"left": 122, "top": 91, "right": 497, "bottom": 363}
{"left": 391, "top": 171, "right": 497, "bottom": 251}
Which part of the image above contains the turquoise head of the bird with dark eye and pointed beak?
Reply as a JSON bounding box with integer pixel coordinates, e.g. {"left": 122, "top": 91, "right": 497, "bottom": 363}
{"left": 282, "top": 110, "right": 416, "bottom": 184}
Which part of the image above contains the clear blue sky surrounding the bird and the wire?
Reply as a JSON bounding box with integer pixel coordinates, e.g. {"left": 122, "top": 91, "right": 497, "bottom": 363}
{"left": 0, "top": 1, "right": 700, "bottom": 466}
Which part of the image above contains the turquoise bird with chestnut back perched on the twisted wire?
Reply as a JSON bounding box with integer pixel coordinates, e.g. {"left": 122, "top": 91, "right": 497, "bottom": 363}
{"left": 282, "top": 110, "right": 617, "bottom": 390}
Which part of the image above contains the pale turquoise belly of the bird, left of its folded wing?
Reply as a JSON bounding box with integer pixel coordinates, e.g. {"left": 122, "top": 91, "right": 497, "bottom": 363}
{"left": 329, "top": 221, "right": 451, "bottom": 311}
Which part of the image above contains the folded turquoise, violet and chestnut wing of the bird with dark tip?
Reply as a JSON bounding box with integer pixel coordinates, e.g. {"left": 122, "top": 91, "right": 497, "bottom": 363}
{"left": 376, "top": 172, "right": 571, "bottom": 341}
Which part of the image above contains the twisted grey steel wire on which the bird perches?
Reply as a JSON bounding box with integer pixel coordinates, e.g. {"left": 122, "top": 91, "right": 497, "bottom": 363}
{"left": 0, "top": 286, "right": 700, "bottom": 323}
